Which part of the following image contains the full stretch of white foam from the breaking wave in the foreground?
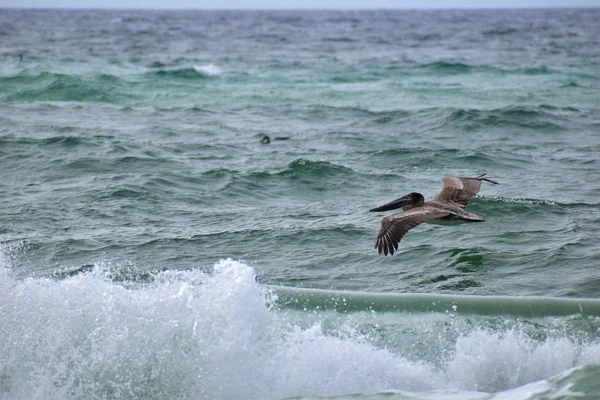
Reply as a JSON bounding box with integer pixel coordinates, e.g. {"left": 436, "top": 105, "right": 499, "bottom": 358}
{"left": 0, "top": 252, "right": 600, "bottom": 399}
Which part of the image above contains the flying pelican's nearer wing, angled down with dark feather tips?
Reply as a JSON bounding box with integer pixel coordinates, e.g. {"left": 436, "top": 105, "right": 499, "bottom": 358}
{"left": 375, "top": 206, "right": 450, "bottom": 256}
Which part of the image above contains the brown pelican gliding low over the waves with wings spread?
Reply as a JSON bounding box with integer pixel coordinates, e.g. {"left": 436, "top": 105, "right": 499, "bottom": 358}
{"left": 369, "top": 174, "right": 498, "bottom": 256}
